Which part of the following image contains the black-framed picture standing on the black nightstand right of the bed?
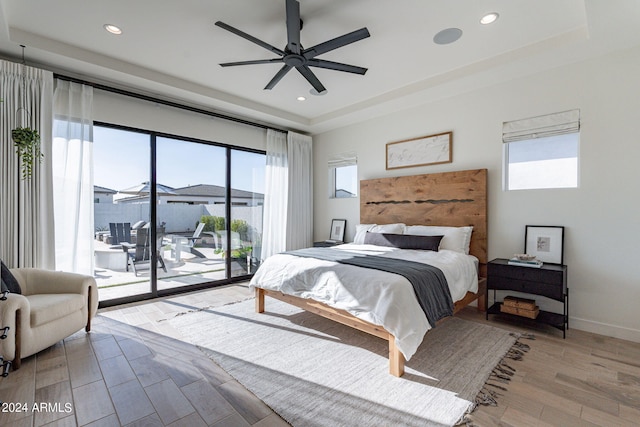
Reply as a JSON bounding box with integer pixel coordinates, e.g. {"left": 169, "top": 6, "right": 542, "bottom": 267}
{"left": 524, "top": 225, "right": 564, "bottom": 265}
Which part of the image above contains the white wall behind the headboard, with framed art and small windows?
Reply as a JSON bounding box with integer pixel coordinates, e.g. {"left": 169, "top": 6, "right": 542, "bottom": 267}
{"left": 314, "top": 44, "right": 640, "bottom": 342}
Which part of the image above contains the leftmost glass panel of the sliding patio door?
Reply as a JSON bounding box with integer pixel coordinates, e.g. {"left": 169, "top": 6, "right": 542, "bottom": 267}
{"left": 93, "top": 126, "right": 151, "bottom": 301}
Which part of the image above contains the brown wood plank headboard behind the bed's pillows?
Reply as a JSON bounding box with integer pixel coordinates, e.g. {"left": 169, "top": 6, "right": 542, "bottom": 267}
{"left": 360, "top": 169, "right": 488, "bottom": 277}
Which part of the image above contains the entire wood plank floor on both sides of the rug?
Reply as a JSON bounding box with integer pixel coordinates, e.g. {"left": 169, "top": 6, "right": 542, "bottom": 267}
{"left": 0, "top": 284, "right": 640, "bottom": 427}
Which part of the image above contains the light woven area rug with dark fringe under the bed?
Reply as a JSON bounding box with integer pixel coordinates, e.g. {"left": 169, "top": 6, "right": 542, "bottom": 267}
{"left": 170, "top": 298, "right": 518, "bottom": 427}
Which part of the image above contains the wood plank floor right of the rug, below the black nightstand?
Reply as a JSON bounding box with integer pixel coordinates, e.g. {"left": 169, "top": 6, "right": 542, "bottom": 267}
{"left": 459, "top": 308, "right": 640, "bottom": 427}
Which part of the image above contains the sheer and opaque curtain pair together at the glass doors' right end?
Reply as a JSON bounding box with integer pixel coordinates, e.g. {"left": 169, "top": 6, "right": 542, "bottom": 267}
{"left": 261, "top": 130, "right": 313, "bottom": 260}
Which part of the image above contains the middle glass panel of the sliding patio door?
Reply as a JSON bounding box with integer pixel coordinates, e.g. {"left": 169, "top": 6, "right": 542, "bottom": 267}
{"left": 156, "top": 137, "right": 227, "bottom": 290}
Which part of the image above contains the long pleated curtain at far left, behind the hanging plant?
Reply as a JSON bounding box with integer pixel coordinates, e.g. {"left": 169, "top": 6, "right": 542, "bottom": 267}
{"left": 0, "top": 60, "right": 54, "bottom": 268}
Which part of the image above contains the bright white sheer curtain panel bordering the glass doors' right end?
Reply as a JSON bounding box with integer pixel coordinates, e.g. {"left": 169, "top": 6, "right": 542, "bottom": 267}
{"left": 260, "top": 129, "right": 289, "bottom": 260}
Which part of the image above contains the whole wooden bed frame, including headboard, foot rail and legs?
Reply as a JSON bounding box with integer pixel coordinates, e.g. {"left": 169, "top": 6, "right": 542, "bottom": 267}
{"left": 255, "top": 169, "right": 488, "bottom": 377}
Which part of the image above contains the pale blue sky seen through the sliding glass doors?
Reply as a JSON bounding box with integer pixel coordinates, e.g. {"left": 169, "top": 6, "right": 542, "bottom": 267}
{"left": 93, "top": 126, "right": 265, "bottom": 193}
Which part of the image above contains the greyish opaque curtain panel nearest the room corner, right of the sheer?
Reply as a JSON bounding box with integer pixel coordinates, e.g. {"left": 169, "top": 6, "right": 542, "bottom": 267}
{"left": 287, "top": 132, "right": 313, "bottom": 250}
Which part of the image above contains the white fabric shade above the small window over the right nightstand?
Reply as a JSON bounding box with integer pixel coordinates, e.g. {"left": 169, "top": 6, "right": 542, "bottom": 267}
{"left": 502, "top": 110, "right": 580, "bottom": 142}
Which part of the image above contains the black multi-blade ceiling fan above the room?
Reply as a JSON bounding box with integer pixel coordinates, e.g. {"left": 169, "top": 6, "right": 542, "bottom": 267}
{"left": 215, "top": 0, "right": 370, "bottom": 93}
